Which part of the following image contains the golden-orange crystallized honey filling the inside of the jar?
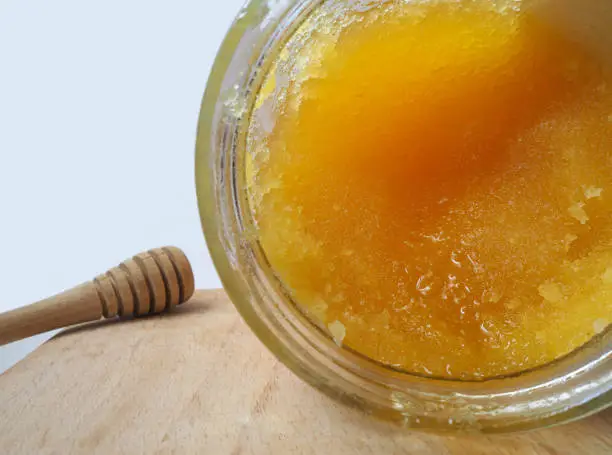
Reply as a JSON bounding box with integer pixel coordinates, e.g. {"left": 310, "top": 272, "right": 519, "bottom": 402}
{"left": 246, "top": 0, "right": 612, "bottom": 379}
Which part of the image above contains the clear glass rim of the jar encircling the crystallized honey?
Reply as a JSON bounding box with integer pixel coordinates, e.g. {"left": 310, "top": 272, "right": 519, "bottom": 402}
{"left": 196, "top": 0, "right": 612, "bottom": 433}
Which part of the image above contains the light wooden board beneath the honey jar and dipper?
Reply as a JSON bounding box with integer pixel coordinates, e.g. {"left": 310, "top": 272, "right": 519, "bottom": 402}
{"left": 0, "top": 291, "right": 612, "bottom": 455}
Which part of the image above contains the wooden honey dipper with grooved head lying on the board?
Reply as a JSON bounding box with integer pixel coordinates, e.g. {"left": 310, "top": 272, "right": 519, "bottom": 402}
{"left": 0, "top": 247, "right": 195, "bottom": 346}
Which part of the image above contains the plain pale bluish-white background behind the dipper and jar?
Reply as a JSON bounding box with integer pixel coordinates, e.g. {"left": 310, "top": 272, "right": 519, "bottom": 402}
{"left": 0, "top": 0, "right": 244, "bottom": 372}
